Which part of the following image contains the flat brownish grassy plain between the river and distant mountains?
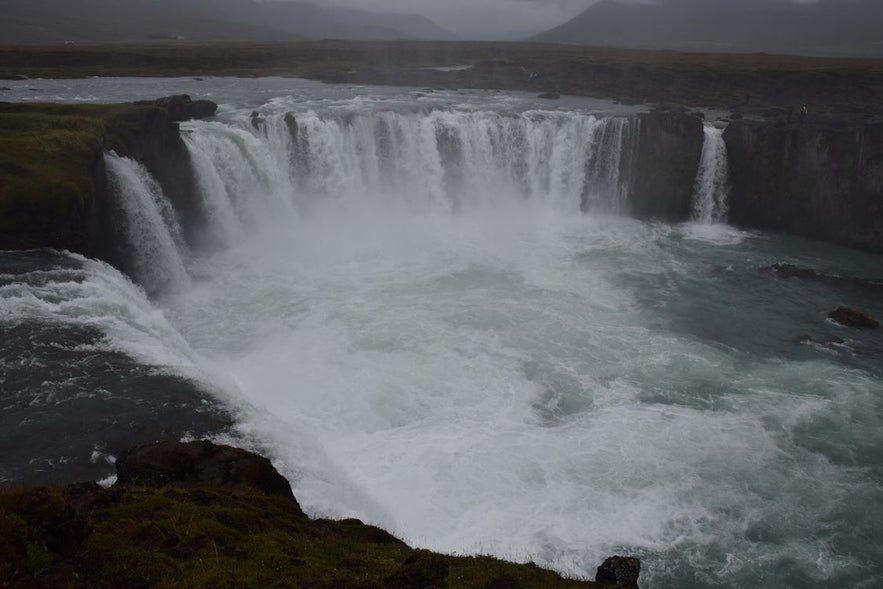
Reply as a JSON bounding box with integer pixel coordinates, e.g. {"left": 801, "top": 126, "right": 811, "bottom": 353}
{"left": 0, "top": 41, "right": 883, "bottom": 117}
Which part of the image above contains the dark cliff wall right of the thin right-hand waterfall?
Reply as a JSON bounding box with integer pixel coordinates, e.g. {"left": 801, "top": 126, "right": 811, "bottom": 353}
{"left": 724, "top": 120, "right": 883, "bottom": 252}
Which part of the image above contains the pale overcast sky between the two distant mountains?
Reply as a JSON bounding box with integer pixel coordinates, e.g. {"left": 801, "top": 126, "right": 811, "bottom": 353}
{"left": 322, "top": 0, "right": 596, "bottom": 35}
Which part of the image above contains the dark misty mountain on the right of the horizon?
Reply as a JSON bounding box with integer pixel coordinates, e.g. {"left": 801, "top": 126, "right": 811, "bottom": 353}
{"left": 531, "top": 0, "right": 883, "bottom": 56}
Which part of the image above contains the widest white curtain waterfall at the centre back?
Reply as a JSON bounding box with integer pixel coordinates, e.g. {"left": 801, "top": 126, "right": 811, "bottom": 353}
{"left": 185, "top": 109, "right": 637, "bottom": 223}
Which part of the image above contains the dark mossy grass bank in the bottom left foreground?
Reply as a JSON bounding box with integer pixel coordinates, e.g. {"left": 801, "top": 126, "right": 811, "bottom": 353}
{"left": 0, "top": 485, "right": 599, "bottom": 589}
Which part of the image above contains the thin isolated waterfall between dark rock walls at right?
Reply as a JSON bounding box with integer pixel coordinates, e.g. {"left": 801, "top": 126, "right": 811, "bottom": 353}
{"left": 693, "top": 125, "right": 729, "bottom": 224}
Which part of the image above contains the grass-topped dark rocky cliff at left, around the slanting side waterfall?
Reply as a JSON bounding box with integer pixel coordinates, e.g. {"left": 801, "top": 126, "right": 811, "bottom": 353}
{"left": 0, "top": 96, "right": 217, "bottom": 263}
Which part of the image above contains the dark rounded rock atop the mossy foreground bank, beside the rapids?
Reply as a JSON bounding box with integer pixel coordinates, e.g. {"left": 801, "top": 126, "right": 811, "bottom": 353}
{"left": 116, "top": 440, "right": 294, "bottom": 501}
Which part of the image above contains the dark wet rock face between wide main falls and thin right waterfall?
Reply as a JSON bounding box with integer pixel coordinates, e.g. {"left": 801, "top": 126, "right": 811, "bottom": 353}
{"left": 630, "top": 108, "right": 705, "bottom": 221}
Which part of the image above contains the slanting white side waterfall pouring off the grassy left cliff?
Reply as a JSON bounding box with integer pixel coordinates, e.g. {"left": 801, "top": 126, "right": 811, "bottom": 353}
{"left": 104, "top": 152, "right": 190, "bottom": 293}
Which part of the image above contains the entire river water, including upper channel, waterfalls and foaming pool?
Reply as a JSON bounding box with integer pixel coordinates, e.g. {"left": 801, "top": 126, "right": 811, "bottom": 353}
{"left": 0, "top": 79, "right": 883, "bottom": 589}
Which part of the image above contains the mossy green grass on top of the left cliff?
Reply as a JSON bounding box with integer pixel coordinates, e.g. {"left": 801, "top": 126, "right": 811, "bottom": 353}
{"left": 0, "top": 103, "right": 157, "bottom": 247}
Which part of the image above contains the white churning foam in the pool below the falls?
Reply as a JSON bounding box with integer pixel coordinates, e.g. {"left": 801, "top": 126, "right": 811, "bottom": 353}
{"left": 162, "top": 203, "right": 880, "bottom": 587}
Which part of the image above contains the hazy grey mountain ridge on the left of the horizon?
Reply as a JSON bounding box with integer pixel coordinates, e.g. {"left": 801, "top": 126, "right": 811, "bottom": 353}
{"left": 0, "top": 0, "right": 454, "bottom": 43}
